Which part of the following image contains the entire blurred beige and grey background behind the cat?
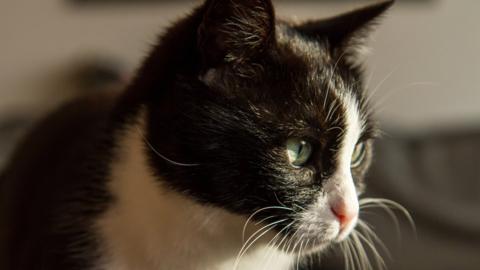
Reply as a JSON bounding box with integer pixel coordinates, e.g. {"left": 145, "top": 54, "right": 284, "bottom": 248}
{"left": 0, "top": 0, "right": 480, "bottom": 269}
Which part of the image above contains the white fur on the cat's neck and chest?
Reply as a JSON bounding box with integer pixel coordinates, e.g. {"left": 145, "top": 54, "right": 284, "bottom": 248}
{"left": 96, "top": 109, "right": 291, "bottom": 270}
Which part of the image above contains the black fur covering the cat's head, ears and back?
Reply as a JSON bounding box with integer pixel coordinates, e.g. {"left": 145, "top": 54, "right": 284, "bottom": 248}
{"left": 1, "top": 0, "right": 391, "bottom": 270}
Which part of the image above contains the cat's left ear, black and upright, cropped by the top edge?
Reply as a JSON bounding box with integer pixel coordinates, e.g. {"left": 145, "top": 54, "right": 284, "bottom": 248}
{"left": 198, "top": 0, "right": 275, "bottom": 68}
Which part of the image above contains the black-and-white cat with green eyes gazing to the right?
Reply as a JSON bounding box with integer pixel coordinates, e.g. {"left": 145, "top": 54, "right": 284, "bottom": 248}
{"left": 0, "top": 0, "right": 393, "bottom": 270}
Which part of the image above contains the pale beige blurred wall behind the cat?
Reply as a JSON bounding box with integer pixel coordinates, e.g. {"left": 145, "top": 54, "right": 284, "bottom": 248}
{"left": 0, "top": 0, "right": 480, "bottom": 130}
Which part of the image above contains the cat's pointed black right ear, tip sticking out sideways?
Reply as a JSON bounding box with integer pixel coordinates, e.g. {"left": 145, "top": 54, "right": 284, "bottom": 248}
{"left": 297, "top": 0, "right": 394, "bottom": 65}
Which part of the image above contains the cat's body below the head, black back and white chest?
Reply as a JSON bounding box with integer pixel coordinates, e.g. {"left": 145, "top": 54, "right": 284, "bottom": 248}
{"left": 2, "top": 91, "right": 292, "bottom": 270}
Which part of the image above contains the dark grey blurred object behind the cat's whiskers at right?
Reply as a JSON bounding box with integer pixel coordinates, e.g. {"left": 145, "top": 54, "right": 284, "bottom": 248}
{"left": 368, "top": 130, "right": 480, "bottom": 270}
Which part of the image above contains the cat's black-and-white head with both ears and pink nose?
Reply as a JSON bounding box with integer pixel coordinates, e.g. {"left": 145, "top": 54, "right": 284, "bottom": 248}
{"left": 148, "top": 0, "right": 392, "bottom": 253}
